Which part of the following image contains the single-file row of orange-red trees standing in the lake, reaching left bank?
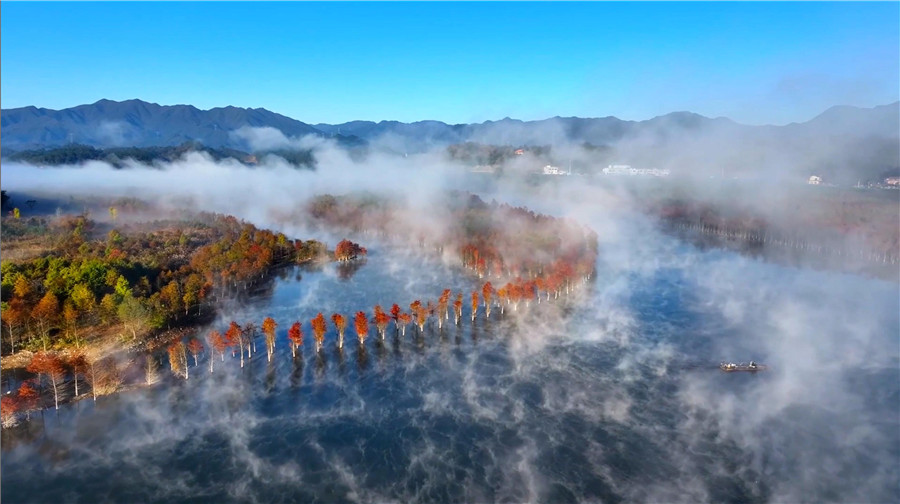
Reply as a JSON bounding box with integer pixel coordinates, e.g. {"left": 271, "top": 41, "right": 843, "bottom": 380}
{"left": 0, "top": 264, "right": 591, "bottom": 427}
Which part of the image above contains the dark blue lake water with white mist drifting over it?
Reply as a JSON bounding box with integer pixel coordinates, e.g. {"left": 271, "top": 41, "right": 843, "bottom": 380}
{"left": 0, "top": 140, "right": 900, "bottom": 502}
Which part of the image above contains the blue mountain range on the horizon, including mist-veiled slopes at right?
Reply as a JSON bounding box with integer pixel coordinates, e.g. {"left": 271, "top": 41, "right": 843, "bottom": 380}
{"left": 0, "top": 100, "right": 900, "bottom": 180}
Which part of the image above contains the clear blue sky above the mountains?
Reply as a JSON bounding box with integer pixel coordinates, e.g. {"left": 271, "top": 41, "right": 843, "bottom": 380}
{"left": 0, "top": 1, "right": 900, "bottom": 124}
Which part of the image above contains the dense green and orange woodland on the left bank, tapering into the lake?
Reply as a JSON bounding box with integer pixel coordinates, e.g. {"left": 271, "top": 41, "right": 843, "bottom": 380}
{"left": 0, "top": 214, "right": 342, "bottom": 353}
